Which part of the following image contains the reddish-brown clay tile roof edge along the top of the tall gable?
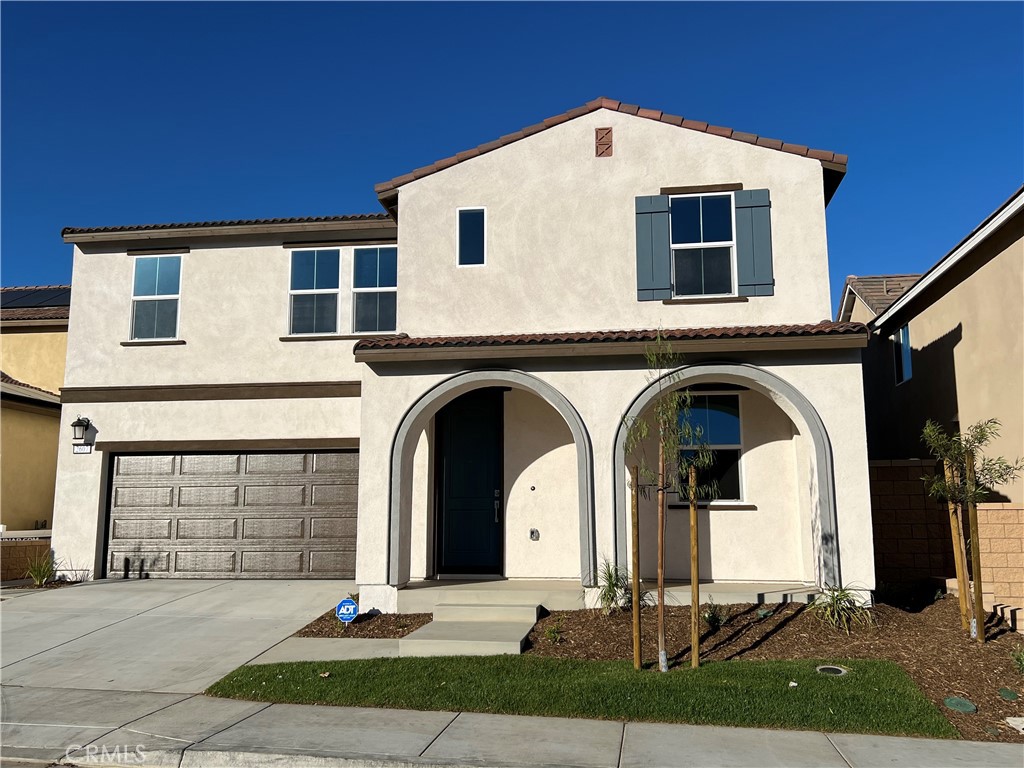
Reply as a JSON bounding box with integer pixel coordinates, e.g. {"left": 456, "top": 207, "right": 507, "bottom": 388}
{"left": 374, "top": 96, "right": 847, "bottom": 197}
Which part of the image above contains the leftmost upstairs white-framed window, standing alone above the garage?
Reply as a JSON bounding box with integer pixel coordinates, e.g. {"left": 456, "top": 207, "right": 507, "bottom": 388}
{"left": 131, "top": 255, "right": 181, "bottom": 340}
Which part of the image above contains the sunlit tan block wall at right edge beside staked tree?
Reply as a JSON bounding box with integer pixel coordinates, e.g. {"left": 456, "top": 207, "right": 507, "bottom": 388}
{"left": 978, "top": 504, "right": 1024, "bottom": 607}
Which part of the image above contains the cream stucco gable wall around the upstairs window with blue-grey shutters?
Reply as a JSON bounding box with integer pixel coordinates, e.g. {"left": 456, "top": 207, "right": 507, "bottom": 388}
{"left": 398, "top": 110, "right": 831, "bottom": 335}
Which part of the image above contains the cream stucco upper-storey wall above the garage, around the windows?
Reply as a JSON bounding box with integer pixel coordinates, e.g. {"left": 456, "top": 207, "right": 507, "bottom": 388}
{"left": 67, "top": 245, "right": 385, "bottom": 387}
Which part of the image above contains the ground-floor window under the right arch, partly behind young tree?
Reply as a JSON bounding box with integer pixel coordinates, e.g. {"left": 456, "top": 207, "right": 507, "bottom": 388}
{"left": 679, "top": 394, "right": 742, "bottom": 501}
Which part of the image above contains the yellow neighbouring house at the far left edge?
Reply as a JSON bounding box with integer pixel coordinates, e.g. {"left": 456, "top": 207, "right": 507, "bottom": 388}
{"left": 0, "top": 286, "right": 71, "bottom": 531}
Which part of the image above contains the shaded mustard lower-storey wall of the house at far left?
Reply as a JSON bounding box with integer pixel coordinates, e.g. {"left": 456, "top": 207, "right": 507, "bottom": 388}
{"left": 0, "top": 402, "right": 60, "bottom": 530}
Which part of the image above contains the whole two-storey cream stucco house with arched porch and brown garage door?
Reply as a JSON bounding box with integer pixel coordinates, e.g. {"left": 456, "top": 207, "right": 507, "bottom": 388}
{"left": 54, "top": 99, "right": 873, "bottom": 611}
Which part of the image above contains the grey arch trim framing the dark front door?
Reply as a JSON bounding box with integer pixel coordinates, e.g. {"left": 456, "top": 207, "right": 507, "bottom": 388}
{"left": 388, "top": 369, "right": 597, "bottom": 587}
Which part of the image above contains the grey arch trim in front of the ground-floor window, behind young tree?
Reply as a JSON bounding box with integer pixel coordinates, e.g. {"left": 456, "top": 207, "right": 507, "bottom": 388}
{"left": 612, "top": 362, "right": 842, "bottom": 585}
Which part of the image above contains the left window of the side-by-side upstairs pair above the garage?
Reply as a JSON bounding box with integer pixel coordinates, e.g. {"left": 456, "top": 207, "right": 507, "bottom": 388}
{"left": 289, "top": 248, "right": 341, "bottom": 335}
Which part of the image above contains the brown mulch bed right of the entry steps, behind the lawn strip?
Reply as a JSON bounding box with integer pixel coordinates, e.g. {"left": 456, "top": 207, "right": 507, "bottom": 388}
{"left": 524, "top": 597, "right": 1024, "bottom": 742}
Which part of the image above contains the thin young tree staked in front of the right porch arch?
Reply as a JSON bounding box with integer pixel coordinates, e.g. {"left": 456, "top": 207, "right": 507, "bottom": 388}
{"left": 626, "top": 333, "right": 717, "bottom": 672}
